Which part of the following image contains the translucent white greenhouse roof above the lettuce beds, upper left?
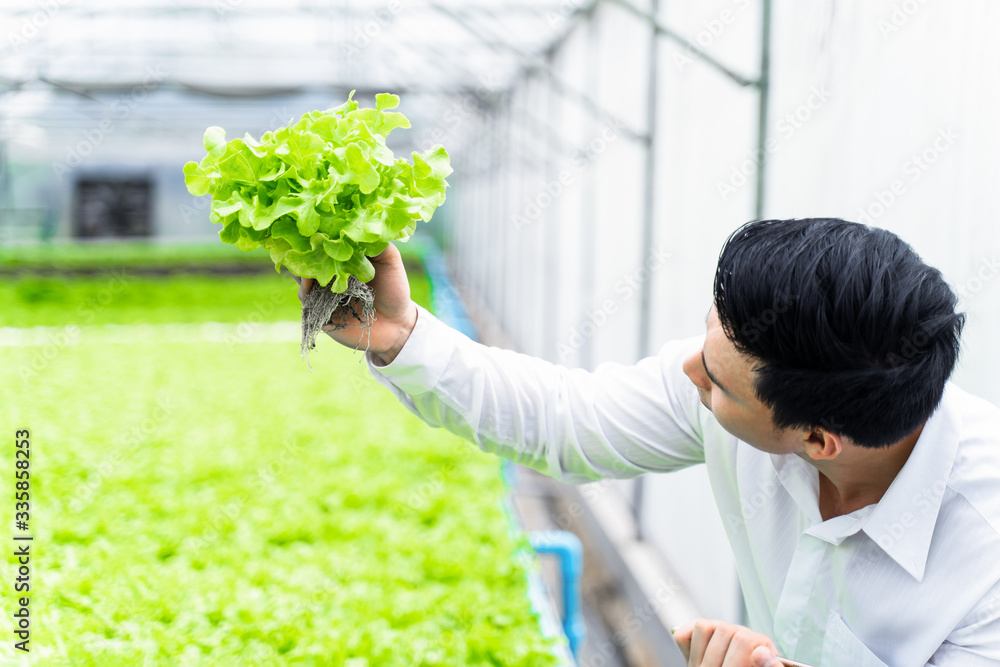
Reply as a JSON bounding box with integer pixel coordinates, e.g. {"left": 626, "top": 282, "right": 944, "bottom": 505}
{"left": 0, "top": 0, "right": 591, "bottom": 98}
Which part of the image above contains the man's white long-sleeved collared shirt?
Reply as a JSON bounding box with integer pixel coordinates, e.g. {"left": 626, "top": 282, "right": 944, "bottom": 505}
{"left": 367, "top": 308, "right": 1000, "bottom": 667}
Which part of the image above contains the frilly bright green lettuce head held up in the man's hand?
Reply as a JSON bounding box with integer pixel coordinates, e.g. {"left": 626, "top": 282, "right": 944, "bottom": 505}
{"left": 184, "top": 91, "right": 452, "bottom": 292}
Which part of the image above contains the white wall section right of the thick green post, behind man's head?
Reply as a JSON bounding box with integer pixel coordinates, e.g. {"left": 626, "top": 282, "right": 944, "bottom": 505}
{"left": 767, "top": 0, "right": 1000, "bottom": 404}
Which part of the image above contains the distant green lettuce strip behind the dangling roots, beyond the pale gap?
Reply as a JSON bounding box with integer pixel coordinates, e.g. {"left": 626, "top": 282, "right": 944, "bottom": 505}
{"left": 0, "top": 243, "right": 431, "bottom": 327}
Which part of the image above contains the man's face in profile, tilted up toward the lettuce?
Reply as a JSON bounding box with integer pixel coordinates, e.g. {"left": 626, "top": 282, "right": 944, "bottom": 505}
{"left": 684, "top": 305, "right": 802, "bottom": 454}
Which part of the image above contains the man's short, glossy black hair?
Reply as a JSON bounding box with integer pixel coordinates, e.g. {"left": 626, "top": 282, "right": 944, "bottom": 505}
{"left": 714, "top": 218, "right": 965, "bottom": 447}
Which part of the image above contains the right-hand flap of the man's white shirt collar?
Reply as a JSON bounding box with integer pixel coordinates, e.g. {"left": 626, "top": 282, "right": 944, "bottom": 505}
{"left": 863, "top": 383, "right": 959, "bottom": 581}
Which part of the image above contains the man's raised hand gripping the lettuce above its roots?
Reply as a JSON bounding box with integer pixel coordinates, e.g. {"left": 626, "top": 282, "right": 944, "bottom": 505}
{"left": 292, "top": 243, "right": 417, "bottom": 365}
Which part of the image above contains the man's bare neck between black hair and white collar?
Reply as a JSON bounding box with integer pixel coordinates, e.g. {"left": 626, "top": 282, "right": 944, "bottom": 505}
{"left": 804, "top": 424, "right": 924, "bottom": 521}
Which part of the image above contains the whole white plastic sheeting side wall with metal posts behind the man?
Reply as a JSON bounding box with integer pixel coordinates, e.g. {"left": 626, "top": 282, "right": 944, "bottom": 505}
{"left": 448, "top": 0, "right": 1000, "bottom": 620}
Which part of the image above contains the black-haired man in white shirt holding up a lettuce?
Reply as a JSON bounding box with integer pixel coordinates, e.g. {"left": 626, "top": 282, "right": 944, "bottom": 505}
{"left": 292, "top": 219, "right": 1000, "bottom": 667}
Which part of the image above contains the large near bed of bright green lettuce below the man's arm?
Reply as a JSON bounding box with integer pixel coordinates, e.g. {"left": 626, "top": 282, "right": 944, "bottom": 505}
{"left": 0, "top": 258, "right": 557, "bottom": 667}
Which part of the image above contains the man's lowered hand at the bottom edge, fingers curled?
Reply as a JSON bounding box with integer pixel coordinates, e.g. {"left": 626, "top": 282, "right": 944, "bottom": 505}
{"left": 674, "top": 619, "right": 781, "bottom": 667}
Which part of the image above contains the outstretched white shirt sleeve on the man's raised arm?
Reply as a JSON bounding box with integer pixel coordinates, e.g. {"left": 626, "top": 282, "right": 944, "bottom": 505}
{"left": 366, "top": 306, "right": 708, "bottom": 484}
